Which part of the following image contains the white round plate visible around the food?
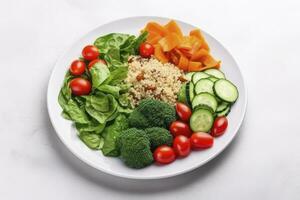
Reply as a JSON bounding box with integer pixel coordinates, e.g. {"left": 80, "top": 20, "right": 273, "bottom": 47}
{"left": 47, "top": 17, "right": 247, "bottom": 179}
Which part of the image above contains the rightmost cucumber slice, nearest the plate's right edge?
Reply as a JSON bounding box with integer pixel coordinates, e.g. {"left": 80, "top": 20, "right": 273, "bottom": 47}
{"left": 213, "top": 79, "right": 239, "bottom": 103}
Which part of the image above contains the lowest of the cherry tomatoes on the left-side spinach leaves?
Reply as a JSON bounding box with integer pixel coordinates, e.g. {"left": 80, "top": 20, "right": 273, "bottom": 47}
{"left": 70, "top": 78, "right": 92, "bottom": 96}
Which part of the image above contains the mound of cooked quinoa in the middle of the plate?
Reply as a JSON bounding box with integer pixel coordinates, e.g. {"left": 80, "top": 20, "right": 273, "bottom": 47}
{"left": 125, "top": 56, "right": 186, "bottom": 106}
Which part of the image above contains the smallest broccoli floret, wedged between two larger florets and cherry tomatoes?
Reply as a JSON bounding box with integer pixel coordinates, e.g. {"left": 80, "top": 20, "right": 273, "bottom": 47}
{"left": 145, "top": 127, "right": 173, "bottom": 151}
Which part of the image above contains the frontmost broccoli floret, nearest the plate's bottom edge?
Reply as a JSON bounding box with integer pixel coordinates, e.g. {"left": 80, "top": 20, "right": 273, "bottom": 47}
{"left": 117, "top": 128, "right": 153, "bottom": 169}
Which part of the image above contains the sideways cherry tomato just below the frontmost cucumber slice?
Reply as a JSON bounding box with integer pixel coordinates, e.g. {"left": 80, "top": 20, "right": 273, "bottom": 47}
{"left": 190, "top": 132, "right": 214, "bottom": 149}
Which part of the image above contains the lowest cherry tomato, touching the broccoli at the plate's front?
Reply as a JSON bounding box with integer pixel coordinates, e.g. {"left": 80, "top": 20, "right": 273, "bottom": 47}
{"left": 153, "top": 145, "right": 176, "bottom": 164}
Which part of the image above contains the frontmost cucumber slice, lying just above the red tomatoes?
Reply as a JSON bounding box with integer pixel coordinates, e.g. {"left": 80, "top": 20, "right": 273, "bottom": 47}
{"left": 190, "top": 108, "right": 214, "bottom": 132}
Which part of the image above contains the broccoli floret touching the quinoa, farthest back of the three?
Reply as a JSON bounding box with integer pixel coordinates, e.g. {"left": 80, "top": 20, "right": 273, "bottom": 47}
{"left": 129, "top": 99, "right": 176, "bottom": 129}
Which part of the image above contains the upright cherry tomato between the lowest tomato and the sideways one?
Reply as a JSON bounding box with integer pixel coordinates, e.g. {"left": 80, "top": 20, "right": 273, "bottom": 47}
{"left": 173, "top": 135, "right": 191, "bottom": 157}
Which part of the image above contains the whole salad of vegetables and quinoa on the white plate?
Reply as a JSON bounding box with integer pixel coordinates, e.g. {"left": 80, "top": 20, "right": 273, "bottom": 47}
{"left": 58, "top": 20, "right": 239, "bottom": 169}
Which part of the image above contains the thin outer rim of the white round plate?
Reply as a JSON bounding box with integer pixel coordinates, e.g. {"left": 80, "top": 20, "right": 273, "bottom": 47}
{"left": 47, "top": 16, "right": 248, "bottom": 180}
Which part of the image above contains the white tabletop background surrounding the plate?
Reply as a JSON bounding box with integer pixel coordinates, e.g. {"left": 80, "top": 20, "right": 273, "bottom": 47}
{"left": 0, "top": 0, "right": 300, "bottom": 200}
